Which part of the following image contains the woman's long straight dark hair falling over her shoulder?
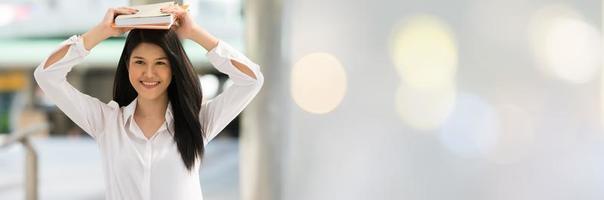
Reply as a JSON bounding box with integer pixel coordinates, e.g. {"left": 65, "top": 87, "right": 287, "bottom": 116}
{"left": 113, "top": 29, "right": 204, "bottom": 171}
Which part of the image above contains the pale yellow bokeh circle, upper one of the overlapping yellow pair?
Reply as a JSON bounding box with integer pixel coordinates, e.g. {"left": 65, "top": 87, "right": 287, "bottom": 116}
{"left": 391, "top": 15, "right": 458, "bottom": 88}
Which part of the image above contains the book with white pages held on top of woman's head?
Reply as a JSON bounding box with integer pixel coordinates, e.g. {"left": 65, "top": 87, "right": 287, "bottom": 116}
{"left": 113, "top": 2, "right": 177, "bottom": 29}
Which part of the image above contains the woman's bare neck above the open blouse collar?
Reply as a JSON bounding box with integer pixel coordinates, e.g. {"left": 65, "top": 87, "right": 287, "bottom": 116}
{"left": 134, "top": 95, "right": 168, "bottom": 119}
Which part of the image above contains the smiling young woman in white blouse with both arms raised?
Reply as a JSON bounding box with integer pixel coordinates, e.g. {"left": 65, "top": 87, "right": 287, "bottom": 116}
{"left": 34, "top": 6, "right": 264, "bottom": 199}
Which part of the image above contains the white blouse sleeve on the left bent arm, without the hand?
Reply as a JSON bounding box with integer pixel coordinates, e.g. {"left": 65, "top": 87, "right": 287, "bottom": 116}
{"left": 34, "top": 35, "right": 119, "bottom": 138}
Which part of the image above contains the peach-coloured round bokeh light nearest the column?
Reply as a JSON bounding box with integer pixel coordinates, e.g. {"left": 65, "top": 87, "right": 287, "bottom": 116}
{"left": 291, "top": 53, "right": 347, "bottom": 114}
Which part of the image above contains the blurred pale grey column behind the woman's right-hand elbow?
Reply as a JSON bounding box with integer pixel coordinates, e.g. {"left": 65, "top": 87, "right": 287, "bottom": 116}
{"left": 240, "top": 0, "right": 291, "bottom": 200}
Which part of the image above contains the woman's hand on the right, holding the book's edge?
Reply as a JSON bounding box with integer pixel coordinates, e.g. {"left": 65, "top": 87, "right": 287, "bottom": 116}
{"left": 161, "top": 5, "right": 200, "bottom": 39}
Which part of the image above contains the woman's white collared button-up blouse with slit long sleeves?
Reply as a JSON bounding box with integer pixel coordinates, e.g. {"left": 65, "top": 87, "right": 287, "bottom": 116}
{"left": 34, "top": 35, "right": 264, "bottom": 200}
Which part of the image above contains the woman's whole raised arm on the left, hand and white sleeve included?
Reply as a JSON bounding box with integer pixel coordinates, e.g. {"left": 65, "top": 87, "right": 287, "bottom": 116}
{"left": 34, "top": 8, "right": 135, "bottom": 138}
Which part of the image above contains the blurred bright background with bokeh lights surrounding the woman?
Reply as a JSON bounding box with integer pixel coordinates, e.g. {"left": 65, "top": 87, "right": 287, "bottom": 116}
{"left": 0, "top": 0, "right": 604, "bottom": 200}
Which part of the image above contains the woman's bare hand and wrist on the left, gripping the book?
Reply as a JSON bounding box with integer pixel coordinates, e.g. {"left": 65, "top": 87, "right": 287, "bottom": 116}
{"left": 82, "top": 7, "right": 138, "bottom": 50}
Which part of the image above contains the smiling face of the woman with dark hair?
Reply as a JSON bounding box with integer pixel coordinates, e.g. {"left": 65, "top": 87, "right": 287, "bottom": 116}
{"left": 128, "top": 43, "right": 172, "bottom": 100}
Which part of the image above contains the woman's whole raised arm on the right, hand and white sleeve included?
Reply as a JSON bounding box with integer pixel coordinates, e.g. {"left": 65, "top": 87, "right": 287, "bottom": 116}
{"left": 162, "top": 3, "right": 264, "bottom": 143}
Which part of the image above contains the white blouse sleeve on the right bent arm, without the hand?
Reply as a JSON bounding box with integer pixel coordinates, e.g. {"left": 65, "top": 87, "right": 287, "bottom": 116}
{"left": 199, "top": 41, "right": 264, "bottom": 143}
